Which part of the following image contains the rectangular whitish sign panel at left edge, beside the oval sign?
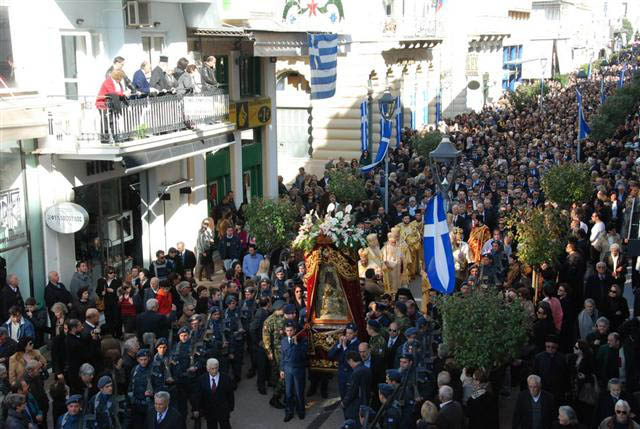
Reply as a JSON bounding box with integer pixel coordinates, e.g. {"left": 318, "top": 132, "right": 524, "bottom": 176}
{"left": 0, "top": 188, "right": 28, "bottom": 250}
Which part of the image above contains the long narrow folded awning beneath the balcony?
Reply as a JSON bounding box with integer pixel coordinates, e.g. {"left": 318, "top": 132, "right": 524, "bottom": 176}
{"left": 122, "top": 133, "right": 235, "bottom": 174}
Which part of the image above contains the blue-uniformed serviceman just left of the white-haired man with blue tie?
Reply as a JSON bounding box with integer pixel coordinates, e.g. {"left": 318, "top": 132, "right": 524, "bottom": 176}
{"left": 170, "top": 326, "right": 197, "bottom": 421}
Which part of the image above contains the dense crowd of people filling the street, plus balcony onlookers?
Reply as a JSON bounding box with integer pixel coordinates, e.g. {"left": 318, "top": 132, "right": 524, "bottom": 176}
{"left": 0, "top": 50, "right": 640, "bottom": 429}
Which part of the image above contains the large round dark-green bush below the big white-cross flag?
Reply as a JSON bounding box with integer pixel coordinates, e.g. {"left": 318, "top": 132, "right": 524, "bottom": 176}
{"left": 436, "top": 288, "right": 530, "bottom": 370}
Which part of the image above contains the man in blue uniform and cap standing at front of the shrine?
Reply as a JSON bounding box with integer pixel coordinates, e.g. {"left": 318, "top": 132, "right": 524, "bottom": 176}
{"left": 280, "top": 320, "right": 307, "bottom": 422}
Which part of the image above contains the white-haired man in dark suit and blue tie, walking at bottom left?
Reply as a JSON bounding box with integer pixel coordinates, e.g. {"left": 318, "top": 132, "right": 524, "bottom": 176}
{"left": 192, "top": 358, "right": 235, "bottom": 429}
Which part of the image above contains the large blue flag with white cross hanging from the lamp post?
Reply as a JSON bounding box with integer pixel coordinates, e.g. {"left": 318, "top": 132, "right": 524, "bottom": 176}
{"left": 424, "top": 192, "right": 456, "bottom": 294}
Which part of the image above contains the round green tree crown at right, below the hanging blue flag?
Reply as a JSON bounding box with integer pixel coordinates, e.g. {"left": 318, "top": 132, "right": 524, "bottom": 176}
{"left": 542, "top": 164, "right": 593, "bottom": 209}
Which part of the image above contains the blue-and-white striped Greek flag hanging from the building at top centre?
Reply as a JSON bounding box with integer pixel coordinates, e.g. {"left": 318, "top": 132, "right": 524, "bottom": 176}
{"left": 309, "top": 34, "right": 338, "bottom": 100}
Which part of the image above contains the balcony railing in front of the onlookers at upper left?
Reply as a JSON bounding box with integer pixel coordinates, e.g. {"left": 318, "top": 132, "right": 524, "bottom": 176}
{"left": 49, "top": 93, "right": 229, "bottom": 145}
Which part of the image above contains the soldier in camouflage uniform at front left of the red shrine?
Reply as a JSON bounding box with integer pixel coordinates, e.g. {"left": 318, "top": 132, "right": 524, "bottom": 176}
{"left": 262, "top": 300, "right": 284, "bottom": 409}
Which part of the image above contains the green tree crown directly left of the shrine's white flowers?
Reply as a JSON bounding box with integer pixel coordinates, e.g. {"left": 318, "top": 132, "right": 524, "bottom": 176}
{"left": 245, "top": 199, "right": 297, "bottom": 254}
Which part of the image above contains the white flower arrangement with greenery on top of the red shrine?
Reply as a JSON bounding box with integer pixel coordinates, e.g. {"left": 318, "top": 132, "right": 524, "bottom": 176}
{"left": 293, "top": 204, "right": 367, "bottom": 252}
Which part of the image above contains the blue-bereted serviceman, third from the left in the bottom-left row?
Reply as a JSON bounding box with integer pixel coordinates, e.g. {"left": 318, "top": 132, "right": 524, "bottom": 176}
{"left": 127, "top": 349, "right": 154, "bottom": 428}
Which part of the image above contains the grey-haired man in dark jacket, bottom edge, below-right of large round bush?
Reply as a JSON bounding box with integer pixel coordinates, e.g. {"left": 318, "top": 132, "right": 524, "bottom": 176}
{"left": 511, "top": 375, "right": 556, "bottom": 429}
